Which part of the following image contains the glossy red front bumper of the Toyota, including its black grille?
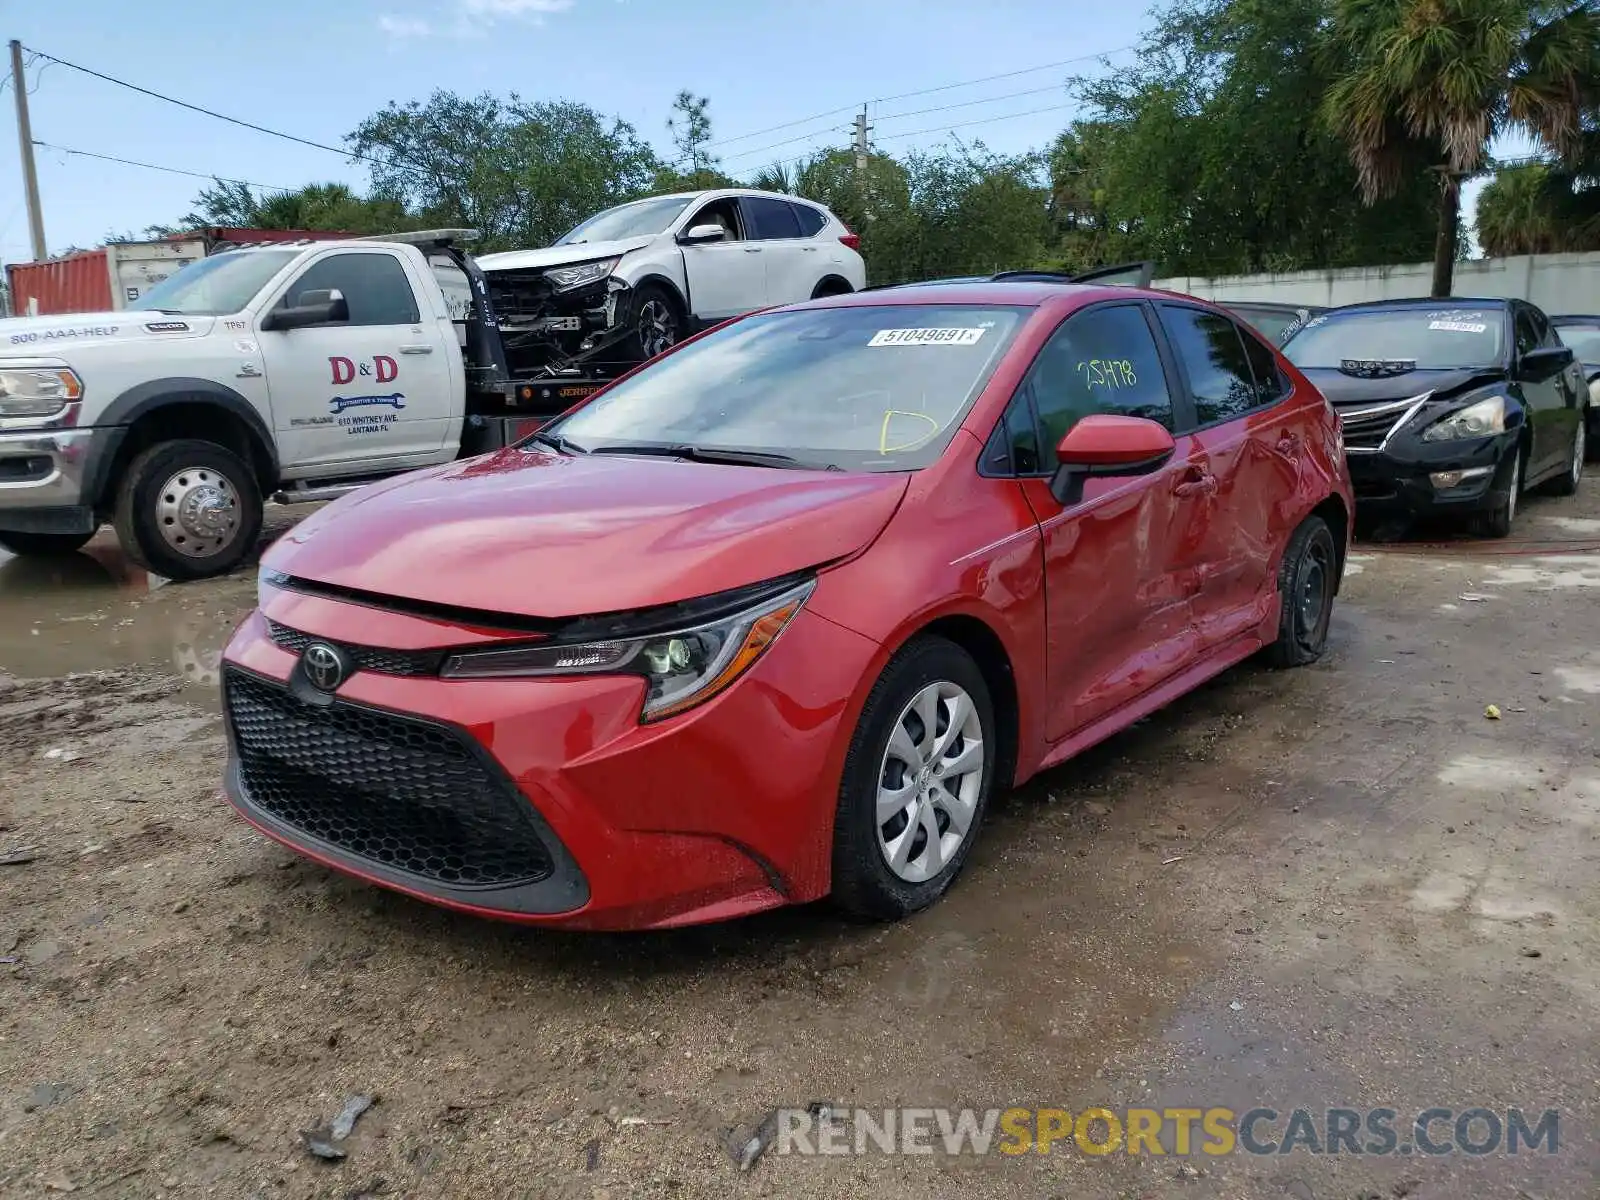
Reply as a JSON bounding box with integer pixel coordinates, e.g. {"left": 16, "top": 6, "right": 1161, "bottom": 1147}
{"left": 224, "top": 592, "right": 875, "bottom": 930}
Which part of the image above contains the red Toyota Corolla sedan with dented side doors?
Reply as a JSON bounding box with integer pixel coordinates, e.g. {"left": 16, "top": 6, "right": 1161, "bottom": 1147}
{"left": 224, "top": 283, "right": 1350, "bottom": 928}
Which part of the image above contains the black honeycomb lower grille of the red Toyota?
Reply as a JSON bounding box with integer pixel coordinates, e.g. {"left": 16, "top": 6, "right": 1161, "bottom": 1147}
{"left": 222, "top": 669, "right": 552, "bottom": 886}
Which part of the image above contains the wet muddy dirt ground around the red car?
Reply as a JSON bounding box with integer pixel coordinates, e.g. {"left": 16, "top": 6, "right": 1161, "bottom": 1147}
{"left": 0, "top": 480, "right": 1600, "bottom": 1200}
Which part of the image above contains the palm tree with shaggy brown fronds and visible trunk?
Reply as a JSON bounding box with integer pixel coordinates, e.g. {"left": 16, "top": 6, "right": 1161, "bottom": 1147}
{"left": 1325, "top": 0, "right": 1600, "bottom": 296}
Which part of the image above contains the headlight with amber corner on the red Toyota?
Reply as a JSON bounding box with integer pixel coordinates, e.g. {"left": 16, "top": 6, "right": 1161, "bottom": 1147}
{"left": 440, "top": 579, "right": 816, "bottom": 722}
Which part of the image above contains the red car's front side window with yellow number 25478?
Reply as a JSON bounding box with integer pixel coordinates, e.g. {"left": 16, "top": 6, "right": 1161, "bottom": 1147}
{"left": 1024, "top": 304, "right": 1173, "bottom": 470}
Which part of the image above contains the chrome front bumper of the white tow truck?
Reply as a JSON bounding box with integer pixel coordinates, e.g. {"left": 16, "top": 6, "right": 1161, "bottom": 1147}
{"left": 0, "top": 427, "right": 122, "bottom": 533}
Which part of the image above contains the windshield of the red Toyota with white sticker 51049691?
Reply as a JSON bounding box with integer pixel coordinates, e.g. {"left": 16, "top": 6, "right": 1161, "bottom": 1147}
{"left": 549, "top": 304, "right": 1029, "bottom": 470}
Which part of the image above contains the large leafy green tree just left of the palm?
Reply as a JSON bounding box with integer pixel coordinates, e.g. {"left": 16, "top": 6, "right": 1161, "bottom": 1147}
{"left": 1068, "top": 0, "right": 1432, "bottom": 275}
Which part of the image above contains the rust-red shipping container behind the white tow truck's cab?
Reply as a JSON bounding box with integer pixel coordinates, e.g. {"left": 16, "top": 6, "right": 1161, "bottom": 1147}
{"left": 6, "top": 227, "right": 352, "bottom": 317}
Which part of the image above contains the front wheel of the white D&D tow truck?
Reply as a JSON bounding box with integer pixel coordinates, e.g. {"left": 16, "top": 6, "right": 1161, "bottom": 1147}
{"left": 117, "top": 440, "right": 261, "bottom": 579}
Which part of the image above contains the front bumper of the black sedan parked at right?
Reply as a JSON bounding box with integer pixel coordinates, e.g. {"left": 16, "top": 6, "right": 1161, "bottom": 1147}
{"left": 1346, "top": 429, "right": 1520, "bottom": 517}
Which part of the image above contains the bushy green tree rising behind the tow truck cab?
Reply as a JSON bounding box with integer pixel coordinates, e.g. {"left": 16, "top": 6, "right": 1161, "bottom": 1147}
{"left": 346, "top": 91, "right": 659, "bottom": 250}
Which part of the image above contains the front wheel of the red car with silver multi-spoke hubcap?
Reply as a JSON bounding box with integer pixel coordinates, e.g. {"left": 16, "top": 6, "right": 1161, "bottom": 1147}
{"left": 834, "top": 637, "right": 1000, "bottom": 920}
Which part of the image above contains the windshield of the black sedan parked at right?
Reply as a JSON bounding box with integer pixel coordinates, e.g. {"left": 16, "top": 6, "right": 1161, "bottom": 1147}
{"left": 1283, "top": 306, "right": 1506, "bottom": 371}
